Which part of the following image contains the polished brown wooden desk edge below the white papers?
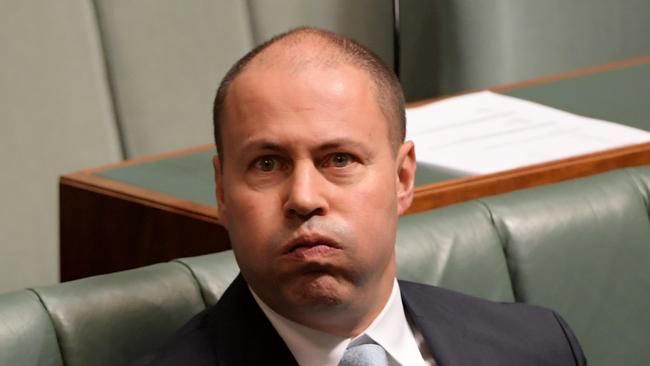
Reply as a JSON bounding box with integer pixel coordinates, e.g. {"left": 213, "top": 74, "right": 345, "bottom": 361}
{"left": 407, "top": 142, "right": 650, "bottom": 214}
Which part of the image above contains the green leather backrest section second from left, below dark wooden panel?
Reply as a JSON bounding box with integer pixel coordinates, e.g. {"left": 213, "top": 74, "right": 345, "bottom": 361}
{"left": 36, "top": 263, "right": 205, "bottom": 366}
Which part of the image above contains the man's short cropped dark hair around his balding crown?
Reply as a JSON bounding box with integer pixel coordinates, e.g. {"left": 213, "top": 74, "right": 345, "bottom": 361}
{"left": 213, "top": 27, "right": 406, "bottom": 164}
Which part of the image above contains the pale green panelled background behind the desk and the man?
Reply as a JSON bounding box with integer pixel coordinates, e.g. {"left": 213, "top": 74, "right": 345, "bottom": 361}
{"left": 0, "top": 0, "right": 650, "bottom": 292}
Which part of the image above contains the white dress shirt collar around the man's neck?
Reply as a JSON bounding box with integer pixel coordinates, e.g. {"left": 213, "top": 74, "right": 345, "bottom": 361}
{"left": 249, "top": 280, "right": 435, "bottom": 366}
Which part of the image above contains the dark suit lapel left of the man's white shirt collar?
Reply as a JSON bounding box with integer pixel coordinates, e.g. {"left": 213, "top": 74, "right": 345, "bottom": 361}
{"left": 208, "top": 274, "right": 297, "bottom": 365}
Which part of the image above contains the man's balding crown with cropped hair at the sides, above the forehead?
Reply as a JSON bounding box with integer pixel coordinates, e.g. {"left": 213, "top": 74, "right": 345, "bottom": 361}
{"left": 213, "top": 28, "right": 406, "bottom": 162}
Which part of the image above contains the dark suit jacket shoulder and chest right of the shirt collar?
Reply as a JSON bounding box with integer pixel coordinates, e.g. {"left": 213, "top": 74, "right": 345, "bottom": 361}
{"left": 400, "top": 281, "right": 586, "bottom": 365}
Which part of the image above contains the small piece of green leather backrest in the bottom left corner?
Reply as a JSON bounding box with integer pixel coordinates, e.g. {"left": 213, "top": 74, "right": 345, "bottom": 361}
{"left": 0, "top": 290, "right": 63, "bottom": 366}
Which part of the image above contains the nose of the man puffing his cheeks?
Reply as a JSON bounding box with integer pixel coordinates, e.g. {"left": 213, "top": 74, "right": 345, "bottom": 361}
{"left": 283, "top": 161, "right": 329, "bottom": 220}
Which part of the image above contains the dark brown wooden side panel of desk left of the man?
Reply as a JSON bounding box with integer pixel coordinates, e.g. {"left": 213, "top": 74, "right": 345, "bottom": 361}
{"left": 59, "top": 177, "right": 230, "bottom": 281}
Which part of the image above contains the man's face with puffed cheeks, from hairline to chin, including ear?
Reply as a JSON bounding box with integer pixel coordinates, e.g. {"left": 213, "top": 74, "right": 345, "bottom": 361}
{"left": 214, "top": 59, "right": 415, "bottom": 332}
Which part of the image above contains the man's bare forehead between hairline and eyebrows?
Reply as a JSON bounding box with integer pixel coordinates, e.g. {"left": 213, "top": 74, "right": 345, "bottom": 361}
{"left": 221, "top": 61, "right": 388, "bottom": 155}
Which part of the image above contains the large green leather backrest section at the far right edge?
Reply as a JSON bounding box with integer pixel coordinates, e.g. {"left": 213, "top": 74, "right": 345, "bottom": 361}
{"left": 485, "top": 171, "right": 650, "bottom": 365}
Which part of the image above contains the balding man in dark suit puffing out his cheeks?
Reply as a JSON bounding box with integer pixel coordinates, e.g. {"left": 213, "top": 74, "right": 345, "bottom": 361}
{"left": 139, "top": 28, "right": 585, "bottom": 366}
